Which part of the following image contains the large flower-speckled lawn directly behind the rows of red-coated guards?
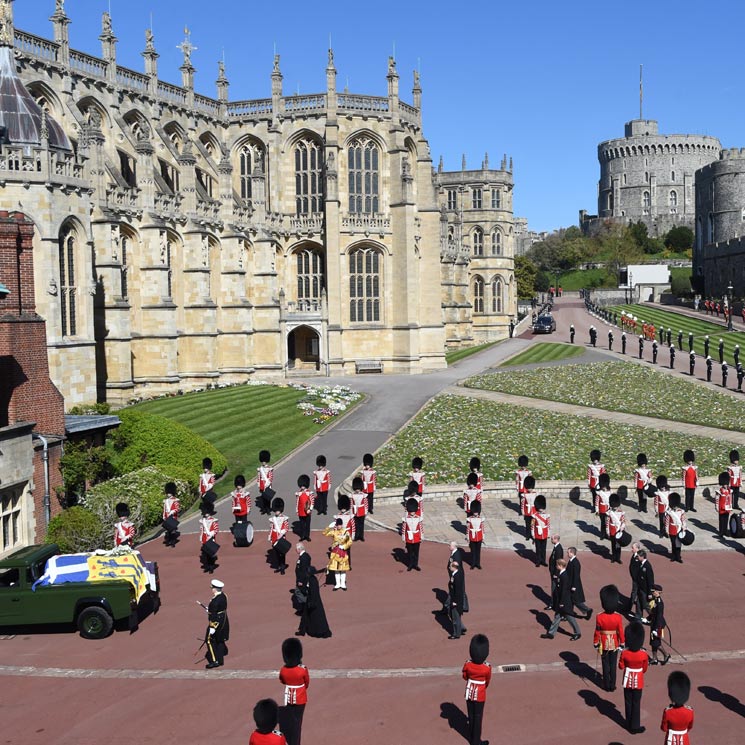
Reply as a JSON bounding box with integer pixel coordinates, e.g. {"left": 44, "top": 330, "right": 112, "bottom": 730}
{"left": 375, "top": 396, "right": 736, "bottom": 487}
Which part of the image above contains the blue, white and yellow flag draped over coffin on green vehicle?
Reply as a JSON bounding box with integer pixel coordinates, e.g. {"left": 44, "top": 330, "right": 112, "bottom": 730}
{"left": 33, "top": 550, "right": 148, "bottom": 601}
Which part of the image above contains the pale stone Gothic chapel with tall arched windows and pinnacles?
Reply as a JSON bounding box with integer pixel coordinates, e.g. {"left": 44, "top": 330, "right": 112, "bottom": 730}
{"left": 0, "top": 2, "right": 515, "bottom": 405}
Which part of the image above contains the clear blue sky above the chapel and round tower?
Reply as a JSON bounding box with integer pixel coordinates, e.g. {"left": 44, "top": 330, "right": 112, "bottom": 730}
{"left": 15, "top": 0, "right": 745, "bottom": 230}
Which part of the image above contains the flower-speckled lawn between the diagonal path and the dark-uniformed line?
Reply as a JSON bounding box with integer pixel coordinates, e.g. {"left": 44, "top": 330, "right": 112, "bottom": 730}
{"left": 466, "top": 360, "right": 745, "bottom": 432}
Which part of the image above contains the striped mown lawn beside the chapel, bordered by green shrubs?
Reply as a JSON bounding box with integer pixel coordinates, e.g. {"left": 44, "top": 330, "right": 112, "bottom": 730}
{"left": 136, "top": 385, "right": 354, "bottom": 496}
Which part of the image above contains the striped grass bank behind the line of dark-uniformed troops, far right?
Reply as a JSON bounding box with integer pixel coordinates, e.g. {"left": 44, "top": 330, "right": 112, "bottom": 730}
{"left": 609, "top": 305, "right": 745, "bottom": 360}
